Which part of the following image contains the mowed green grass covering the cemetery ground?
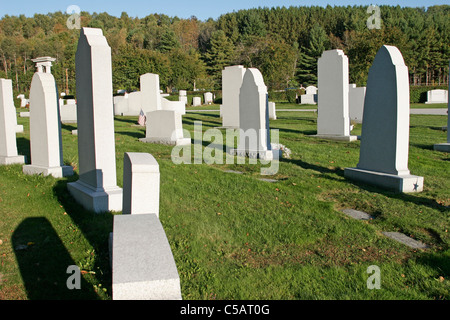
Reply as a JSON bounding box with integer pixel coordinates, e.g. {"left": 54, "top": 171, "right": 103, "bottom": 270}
{"left": 0, "top": 107, "right": 450, "bottom": 300}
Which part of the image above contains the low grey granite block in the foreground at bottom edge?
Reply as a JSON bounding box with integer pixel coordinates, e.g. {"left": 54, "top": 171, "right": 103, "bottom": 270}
{"left": 110, "top": 214, "right": 181, "bottom": 300}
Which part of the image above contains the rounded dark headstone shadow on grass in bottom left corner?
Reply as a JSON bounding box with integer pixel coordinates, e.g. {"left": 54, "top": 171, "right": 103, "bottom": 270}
{"left": 12, "top": 217, "right": 98, "bottom": 300}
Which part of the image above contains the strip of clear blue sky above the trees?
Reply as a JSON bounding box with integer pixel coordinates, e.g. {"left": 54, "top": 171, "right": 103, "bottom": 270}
{"left": 0, "top": 0, "right": 449, "bottom": 20}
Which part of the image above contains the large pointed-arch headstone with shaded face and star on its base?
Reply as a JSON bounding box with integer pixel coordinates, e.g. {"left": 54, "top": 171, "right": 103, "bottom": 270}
{"left": 345, "top": 45, "right": 423, "bottom": 192}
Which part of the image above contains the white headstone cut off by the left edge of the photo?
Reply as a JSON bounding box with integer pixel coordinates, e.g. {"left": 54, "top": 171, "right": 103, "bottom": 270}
{"left": 0, "top": 79, "right": 25, "bottom": 165}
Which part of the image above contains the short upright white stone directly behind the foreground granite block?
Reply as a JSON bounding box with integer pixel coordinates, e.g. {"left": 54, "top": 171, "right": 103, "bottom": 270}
{"left": 122, "top": 152, "right": 160, "bottom": 217}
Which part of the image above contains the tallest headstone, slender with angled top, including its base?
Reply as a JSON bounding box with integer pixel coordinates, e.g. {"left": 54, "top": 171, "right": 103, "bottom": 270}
{"left": 67, "top": 28, "right": 122, "bottom": 212}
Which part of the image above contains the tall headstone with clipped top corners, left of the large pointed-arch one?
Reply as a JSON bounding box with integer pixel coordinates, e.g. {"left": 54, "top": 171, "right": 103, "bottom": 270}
{"left": 317, "top": 49, "right": 357, "bottom": 141}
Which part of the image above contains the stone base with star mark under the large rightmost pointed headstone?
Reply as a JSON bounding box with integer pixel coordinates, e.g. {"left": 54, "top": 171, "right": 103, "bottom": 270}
{"left": 344, "top": 168, "right": 424, "bottom": 193}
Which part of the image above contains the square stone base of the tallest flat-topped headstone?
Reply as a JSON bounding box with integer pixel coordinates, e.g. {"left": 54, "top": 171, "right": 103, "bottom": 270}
{"left": 67, "top": 180, "right": 123, "bottom": 213}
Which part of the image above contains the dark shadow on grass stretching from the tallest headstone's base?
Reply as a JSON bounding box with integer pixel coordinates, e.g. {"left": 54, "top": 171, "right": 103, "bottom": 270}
{"left": 53, "top": 178, "right": 114, "bottom": 299}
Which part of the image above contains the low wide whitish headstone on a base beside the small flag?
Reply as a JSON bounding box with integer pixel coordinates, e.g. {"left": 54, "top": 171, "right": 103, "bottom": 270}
{"left": 139, "top": 110, "right": 191, "bottom": 145}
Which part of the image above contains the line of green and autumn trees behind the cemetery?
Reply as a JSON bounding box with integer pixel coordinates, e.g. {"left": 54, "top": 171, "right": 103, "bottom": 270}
{"left": 0, "top": 5, "right": 450, "bottom": 94}
